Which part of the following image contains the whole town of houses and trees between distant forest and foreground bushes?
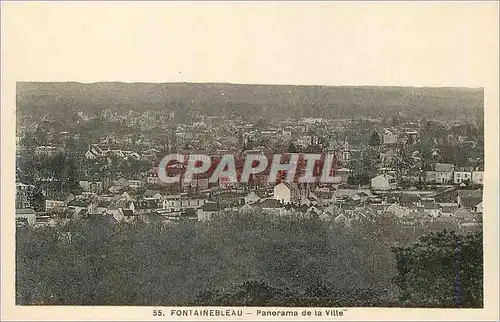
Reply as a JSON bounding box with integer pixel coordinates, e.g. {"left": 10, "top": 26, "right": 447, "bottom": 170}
{"left": 16, "top": 103, "right": 484, "bottom": 229}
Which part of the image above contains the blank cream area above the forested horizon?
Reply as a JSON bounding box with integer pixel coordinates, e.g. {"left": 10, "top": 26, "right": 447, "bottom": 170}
{"left": 2, "top": 2, "right": 498, "bottom": 87}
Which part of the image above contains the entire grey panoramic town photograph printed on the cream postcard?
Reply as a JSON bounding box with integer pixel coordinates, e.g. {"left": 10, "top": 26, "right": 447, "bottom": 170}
{"left": 13, "top": 82, "right": 485, "bottom": 306}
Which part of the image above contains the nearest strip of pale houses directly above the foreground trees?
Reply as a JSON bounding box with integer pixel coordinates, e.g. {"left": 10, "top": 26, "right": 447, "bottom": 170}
{"left": 16, "top": 182, "right": 483, "bottom": 234}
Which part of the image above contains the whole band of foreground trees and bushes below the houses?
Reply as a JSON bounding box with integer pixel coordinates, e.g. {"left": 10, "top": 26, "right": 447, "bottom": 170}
{"left": 16, "top": 214, "right": 483, "bottom": 307}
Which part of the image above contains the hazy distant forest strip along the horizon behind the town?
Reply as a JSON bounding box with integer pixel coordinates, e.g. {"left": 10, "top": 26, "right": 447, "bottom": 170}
{"left": 17, "top": 82, "right": 483, "bottom": 123}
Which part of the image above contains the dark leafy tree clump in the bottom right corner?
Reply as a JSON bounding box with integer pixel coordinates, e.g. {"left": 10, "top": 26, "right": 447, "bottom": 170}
{"left": 393, "top": 230, "right": 483, "bottom": 308}
